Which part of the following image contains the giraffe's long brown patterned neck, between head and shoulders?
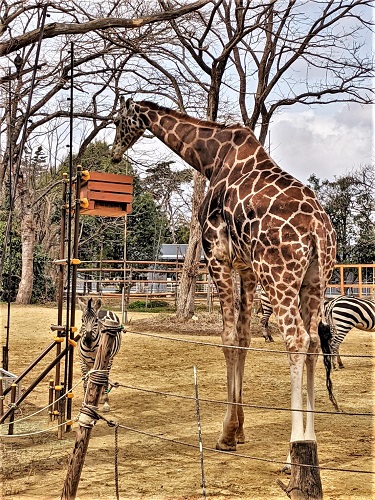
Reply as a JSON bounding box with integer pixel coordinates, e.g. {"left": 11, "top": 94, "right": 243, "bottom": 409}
{"left": 138, "top": 101, "right": 260, "bottom": 179}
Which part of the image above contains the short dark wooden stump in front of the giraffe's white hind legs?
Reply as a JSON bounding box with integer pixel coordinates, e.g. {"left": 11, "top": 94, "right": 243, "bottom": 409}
{"left": 277, "top": 441, "right": 323, "bottom": 500}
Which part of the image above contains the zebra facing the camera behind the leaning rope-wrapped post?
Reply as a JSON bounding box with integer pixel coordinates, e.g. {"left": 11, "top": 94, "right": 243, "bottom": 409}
{"left": 78, "top": 297, "right": 121, "bottom": 412}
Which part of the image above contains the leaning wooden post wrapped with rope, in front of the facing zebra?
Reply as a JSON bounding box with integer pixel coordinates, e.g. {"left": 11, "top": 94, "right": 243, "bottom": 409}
{"left": 61, "top": 322, "right": 121, "bottom": 500}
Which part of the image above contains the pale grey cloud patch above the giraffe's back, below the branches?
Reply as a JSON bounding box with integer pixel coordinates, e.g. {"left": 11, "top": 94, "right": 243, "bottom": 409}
{"left": 267, "top": 105, "right": 374, "bottom": 182}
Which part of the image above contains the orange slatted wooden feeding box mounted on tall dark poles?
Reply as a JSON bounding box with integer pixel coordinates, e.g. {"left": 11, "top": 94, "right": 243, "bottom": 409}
{"left": 80, "top": 172, "right": 133, "bottom": 217}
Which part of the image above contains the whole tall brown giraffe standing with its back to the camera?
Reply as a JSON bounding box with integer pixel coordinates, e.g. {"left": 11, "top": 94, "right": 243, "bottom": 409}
{"left": 112, "top": 97, "right": 336, "bottom": 451}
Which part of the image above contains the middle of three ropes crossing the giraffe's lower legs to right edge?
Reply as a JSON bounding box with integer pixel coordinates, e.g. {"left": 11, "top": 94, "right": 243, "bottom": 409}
{"left": 113, "top": 382, "right": 375, "bottom": 417}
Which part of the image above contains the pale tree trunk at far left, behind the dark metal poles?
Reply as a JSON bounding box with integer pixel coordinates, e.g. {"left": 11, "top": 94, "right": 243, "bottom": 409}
{"left": 16, "top": 208, "right": 35, "bottom": 304}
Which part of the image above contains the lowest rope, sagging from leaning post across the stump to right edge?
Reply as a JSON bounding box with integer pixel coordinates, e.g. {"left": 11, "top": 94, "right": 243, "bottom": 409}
{"left": 94, "top": 414, "right": 375, "bottom": 474}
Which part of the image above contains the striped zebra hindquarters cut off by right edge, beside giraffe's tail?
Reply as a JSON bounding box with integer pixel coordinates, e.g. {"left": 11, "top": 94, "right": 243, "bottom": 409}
{"left": 324, "top": 295, "right": 375, "bottom": 370}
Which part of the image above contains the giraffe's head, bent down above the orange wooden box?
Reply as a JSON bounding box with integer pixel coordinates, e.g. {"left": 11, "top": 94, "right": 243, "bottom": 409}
{"left": 112, "top": 97, "right": 146, "bottom": 163}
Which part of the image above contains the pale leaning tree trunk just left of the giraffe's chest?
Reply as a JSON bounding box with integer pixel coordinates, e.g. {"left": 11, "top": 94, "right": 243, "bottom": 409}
{"left": 176, "top": 172, "right": 206, "bottom": 320}
